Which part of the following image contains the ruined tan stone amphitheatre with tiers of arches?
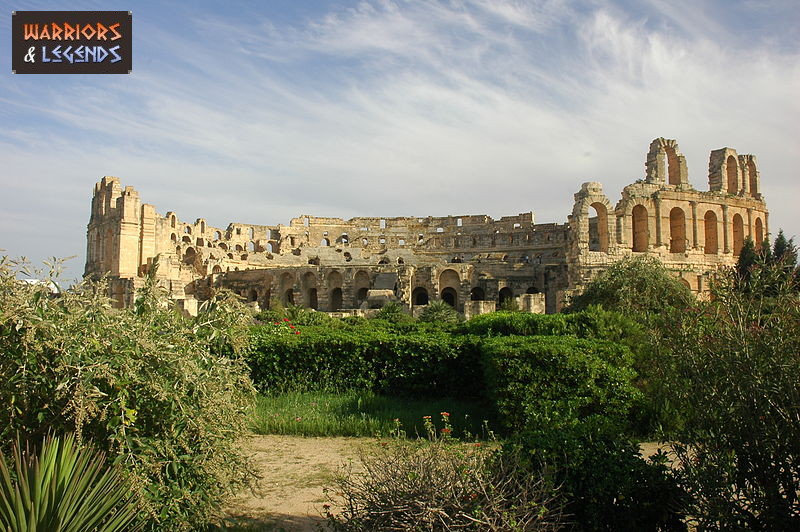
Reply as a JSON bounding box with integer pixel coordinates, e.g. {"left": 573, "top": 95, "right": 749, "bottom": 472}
{"left": 85, "top": 138, "right": 768, "bottom": 316}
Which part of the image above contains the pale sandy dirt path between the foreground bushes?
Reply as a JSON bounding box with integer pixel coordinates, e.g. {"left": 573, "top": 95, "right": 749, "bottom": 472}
{"left": 222, "top": 435, "right": 375, "bottom": 532}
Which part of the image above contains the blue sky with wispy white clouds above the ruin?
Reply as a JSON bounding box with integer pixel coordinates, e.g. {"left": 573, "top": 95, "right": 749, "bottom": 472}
{"left": 0, "top": 0, "right": 800, "bottom": 277}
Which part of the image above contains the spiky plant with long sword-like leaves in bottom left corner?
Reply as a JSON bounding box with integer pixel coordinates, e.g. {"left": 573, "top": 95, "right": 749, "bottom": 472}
{"left": 0, "top": 435, "right": 144, "bottom": 532}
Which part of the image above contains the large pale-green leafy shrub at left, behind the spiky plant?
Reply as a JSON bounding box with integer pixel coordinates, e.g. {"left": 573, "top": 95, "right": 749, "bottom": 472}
{"left": 0, "top": 258, "right": 254, "bottom": 530}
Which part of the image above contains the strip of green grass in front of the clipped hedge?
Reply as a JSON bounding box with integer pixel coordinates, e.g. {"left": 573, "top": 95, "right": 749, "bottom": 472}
{"left": 250, "top": 391, "right": 493, "bottom": 439}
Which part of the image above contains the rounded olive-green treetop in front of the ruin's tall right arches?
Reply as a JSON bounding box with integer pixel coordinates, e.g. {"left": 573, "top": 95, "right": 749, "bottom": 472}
{"left": 567, "top": 255, "right": 696, "bottom": 319}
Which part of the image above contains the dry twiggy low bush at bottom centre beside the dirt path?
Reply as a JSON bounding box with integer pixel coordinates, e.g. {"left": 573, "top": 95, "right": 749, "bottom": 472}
{"left": 327, "top": 438, "right": 563, "bottom": 532}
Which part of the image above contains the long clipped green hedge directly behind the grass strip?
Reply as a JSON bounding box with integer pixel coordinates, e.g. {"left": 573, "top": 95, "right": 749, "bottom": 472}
{"left": 248, "top": 320, "right": 483, "bottom": 397}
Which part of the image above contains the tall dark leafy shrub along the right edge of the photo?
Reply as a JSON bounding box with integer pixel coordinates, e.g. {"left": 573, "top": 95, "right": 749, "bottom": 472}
{"left": 658, "top": 266, "right": 800, "bottom": 530}
